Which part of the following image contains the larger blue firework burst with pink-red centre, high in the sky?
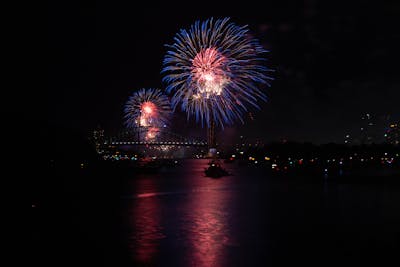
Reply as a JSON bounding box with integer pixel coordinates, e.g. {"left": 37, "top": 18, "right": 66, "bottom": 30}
{"left": 162, "top": 18, "right": 272, "bottom": 127}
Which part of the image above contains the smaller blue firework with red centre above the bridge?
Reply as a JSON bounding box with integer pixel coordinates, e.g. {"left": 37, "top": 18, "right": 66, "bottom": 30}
{"left": 124, "top": 88, "right": 171, "bottom": 139}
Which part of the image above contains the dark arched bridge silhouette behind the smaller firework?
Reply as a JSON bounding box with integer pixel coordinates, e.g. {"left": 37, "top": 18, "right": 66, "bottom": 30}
{"left": 103, "top": 127, "right": 208, "bottom": 147}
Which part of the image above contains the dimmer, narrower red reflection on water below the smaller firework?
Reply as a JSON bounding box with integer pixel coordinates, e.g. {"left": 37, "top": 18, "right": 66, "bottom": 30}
{"left": 131, "top": 179, "right": 165, "bottom": 263}
